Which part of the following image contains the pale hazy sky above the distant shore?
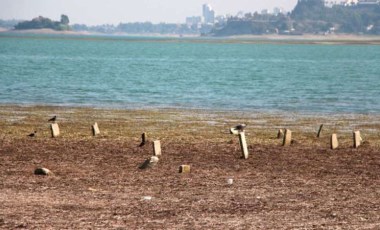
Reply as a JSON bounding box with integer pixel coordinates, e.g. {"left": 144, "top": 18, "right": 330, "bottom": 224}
{"left": 0, "top": 0, "right": 297, "bottom": 25}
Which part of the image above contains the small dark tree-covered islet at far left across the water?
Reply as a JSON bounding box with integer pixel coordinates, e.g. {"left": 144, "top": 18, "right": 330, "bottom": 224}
{"left": 15, "top": 14, "right": 70, "bottom": 31}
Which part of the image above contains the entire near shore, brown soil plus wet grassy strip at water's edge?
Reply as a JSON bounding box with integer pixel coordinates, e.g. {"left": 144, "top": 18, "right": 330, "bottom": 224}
{"left": 0, "top": 106, "right": 380, "bottom": 229}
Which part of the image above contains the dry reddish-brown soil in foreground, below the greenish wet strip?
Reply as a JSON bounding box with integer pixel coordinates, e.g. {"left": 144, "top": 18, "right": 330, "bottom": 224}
{"left": 0, "top": 135, "right": 380, "bottom": 229}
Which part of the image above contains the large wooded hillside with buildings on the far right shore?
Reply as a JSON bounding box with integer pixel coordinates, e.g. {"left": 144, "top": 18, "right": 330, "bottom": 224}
{"left": 210, "top": 0, "right": 380, "bottom": 36}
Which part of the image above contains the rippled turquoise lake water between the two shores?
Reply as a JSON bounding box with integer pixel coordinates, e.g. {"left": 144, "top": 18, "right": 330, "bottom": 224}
{"left": 0, "top": 36, "right": 380, "bottom": 114}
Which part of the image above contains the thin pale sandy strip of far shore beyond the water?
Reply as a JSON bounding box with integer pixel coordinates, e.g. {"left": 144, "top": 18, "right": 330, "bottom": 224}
{"left": 0, "top": 28, "right": 380, "bottom": 45}
